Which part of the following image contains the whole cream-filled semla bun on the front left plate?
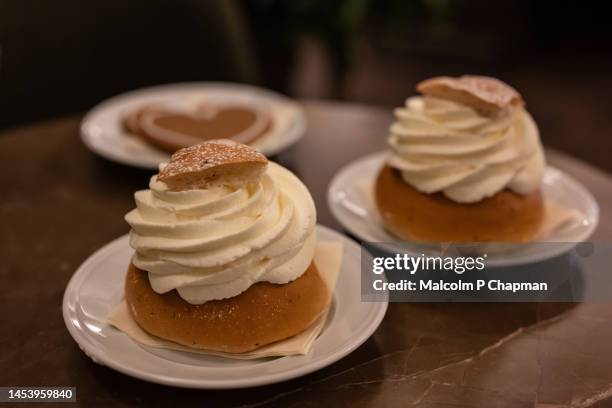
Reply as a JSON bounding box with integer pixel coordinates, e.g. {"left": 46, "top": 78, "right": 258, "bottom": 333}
{"left": 125, "top": 140, "right": 330, "bottom": 353}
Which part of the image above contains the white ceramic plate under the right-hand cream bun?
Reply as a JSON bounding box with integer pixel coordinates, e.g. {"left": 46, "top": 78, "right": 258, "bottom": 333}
{"left": 327, "top": 151, "right": 599, "bottom": 266}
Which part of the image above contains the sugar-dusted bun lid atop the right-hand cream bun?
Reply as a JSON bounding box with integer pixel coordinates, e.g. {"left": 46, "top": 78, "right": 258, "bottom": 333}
{"left": 417, "top": 75, "right": 523, "bottom": 114}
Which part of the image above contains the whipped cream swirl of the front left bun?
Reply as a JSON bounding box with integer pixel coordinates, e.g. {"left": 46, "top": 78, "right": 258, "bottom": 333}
{"left": 125, "top": 162, "right": 316, "bottom": 304}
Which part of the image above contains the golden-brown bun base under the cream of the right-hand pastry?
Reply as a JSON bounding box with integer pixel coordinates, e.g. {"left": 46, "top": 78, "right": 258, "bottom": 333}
{"left": 375, "top": 165, "right": 544, "bottom": 242}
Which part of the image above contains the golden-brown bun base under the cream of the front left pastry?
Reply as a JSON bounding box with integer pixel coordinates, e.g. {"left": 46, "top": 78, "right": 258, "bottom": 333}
{"left": 125, "top": 263, "right": 329, "bottom": 353}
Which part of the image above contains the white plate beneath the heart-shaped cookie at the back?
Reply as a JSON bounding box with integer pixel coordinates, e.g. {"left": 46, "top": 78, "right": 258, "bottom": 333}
{"left": 81, "top": 82, "right": 306, "bottom": 169}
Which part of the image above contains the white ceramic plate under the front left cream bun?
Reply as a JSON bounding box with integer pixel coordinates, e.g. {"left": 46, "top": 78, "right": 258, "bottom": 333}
{"left": 63, "top": 226, "right": 387, "bottom": 389}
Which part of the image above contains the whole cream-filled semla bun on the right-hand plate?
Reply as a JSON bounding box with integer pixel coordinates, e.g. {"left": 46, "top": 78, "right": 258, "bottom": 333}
{"left": 375, "top": 76, "right": 545, "bottom": 242}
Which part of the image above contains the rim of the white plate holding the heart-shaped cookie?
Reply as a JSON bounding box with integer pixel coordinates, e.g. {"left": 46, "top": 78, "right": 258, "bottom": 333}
{"left": 79, "top": 81, "right": 308, "bottom": 170}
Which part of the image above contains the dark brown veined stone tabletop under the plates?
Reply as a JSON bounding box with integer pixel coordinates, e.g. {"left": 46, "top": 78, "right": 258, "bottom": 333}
{"left": 0, "top": 102, "right": 612, "bottom": 407}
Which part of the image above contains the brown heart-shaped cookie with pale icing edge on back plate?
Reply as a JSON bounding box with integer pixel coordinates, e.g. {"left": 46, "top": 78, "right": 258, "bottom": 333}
{"left": 124, "top": 103, "right": 271, "bottom": 152}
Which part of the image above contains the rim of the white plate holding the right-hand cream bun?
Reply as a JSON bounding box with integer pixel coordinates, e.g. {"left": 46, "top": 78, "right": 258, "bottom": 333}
{"left": 326, "top": 150, "right": 601, "bottom": 266}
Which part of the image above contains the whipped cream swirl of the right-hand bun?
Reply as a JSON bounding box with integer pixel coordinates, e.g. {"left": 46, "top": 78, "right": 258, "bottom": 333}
{"left": 388, "top": 96, "right": 545, "bottom": 203}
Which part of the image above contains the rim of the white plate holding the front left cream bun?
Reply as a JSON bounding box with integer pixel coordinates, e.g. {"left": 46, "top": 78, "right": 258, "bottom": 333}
{"left": 62, "top": 224, "right": 389, "bottom": 389}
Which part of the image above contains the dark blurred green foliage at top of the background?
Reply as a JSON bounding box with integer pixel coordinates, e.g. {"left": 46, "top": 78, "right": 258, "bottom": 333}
{"left": 246, "top": 0, "right": 452, "bottom": 76}
